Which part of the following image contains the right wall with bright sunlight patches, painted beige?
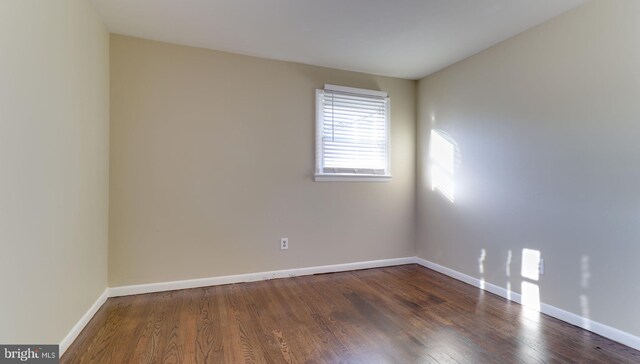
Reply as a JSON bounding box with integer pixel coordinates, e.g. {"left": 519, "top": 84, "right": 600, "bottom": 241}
{"left": 417, "top": 0, "right": 640, "bottom": 335}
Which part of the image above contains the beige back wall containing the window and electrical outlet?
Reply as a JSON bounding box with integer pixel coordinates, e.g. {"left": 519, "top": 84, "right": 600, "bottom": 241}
{"left": 109, "top": 35, "right": 416, "bottom": 286}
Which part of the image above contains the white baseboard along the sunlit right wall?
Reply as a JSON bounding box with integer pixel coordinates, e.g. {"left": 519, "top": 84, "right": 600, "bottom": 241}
{"left": 414, "top": 257, "right": 640, "bottom": 350}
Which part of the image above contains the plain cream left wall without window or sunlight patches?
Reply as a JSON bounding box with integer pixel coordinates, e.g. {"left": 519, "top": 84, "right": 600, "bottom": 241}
{"left": 0, "top": 0, "right": 109, "bottom": 344}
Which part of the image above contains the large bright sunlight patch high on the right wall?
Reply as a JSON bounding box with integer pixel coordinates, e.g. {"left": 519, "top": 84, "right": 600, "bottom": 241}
{"left": 429, "top": 130, "right": 455, "bottom": 202}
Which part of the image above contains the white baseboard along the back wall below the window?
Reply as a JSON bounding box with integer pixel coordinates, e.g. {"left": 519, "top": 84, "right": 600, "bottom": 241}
{"left": 109, "top": 257, "right": 415, "bottom": 297}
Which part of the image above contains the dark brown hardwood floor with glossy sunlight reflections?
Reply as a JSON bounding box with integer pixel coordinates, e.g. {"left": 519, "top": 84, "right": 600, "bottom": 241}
{"left": 61, "top": 265, "right": 640, "bottom": 363}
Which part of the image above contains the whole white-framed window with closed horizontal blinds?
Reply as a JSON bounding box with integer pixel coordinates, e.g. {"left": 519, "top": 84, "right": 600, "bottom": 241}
{"left": 315, "top": 85, "right": 391, "bottom": 181}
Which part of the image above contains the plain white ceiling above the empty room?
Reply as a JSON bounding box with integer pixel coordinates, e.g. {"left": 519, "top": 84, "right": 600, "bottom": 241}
{"left": 93, "top": 0, "right": 585, "bottom": 79}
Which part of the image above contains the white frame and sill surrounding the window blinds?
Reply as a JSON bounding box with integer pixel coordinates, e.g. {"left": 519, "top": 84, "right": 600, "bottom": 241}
{"left": 314, "top": 84, "right": 392, "bottom": 182}
